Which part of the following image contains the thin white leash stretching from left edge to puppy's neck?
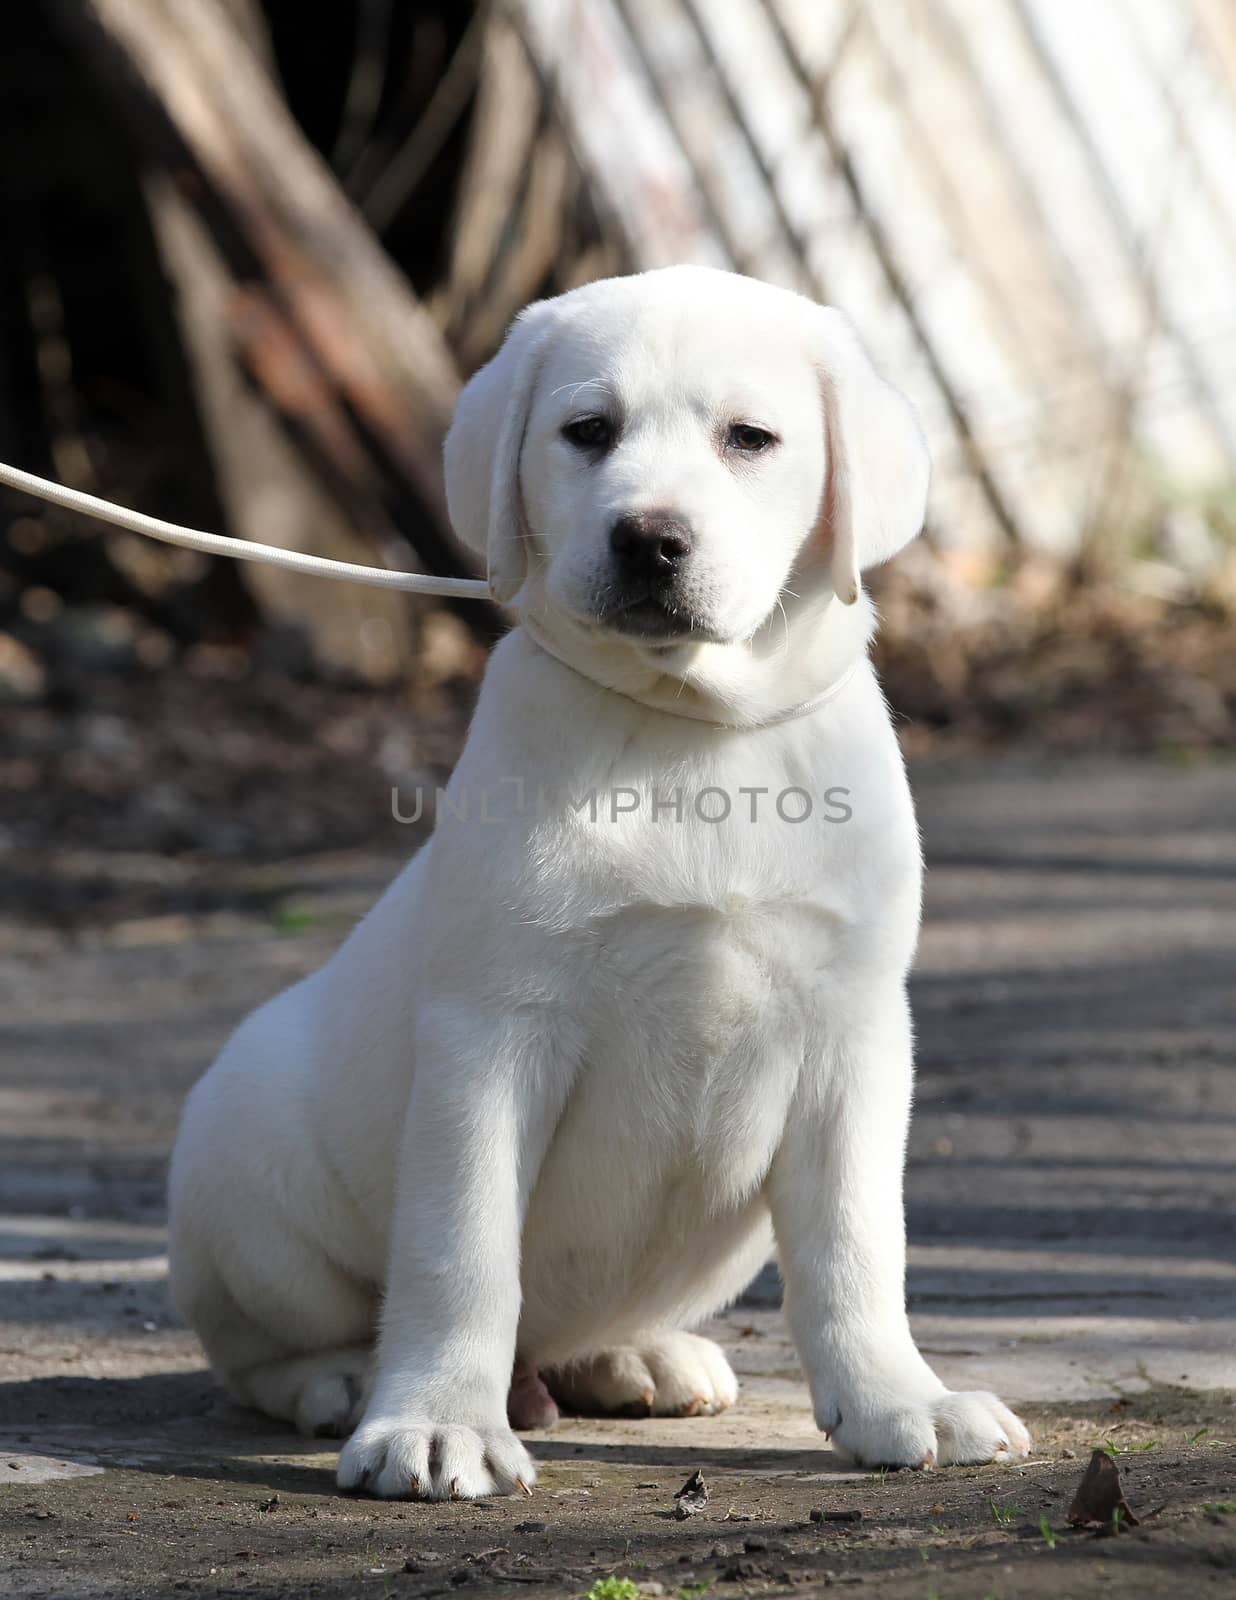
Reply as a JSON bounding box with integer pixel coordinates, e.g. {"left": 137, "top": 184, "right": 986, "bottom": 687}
{"left": 0, "top": 461, "right": 493, "bottom": 600}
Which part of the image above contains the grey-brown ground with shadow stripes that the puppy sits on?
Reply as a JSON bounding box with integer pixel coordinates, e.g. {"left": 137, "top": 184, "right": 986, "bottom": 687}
{"left": 0, "top": 755, "right": 1236, "bottom": 1600}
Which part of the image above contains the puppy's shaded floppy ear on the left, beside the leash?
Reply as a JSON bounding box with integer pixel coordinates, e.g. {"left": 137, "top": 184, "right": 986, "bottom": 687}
{"left": 443, "top": 301, "right": 554, "bottom": 602}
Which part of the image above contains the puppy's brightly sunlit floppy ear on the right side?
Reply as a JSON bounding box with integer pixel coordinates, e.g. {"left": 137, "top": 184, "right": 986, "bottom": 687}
{"left": 817, "top": 306, "right": 930, "bottom": 605}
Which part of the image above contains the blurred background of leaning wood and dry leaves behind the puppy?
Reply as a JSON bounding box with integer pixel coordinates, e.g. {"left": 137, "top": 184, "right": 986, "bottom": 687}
{"left": 0, "top": 0, "right": 1236, "bottom": 918}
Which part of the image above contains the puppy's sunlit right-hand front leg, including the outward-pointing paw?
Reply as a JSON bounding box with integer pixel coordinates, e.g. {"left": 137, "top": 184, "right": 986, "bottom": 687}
{"left": 768, "top": 986, "right": 1029, "bottom": 1467}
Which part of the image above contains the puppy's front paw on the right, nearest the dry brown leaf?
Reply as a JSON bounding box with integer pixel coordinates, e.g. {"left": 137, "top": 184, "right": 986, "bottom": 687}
{"left": 826, "top": 1390, "right": 1029, "bottom": 1467}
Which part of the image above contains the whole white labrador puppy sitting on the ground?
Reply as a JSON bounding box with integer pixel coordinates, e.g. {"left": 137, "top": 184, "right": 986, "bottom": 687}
{"left": 171, "top": 267, "right": 1029, "bottom": 1498}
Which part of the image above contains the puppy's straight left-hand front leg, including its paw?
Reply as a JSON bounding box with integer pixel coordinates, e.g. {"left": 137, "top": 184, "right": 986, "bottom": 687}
{"left": 338, "top": 1006, "right": 564, "bottom": 1499}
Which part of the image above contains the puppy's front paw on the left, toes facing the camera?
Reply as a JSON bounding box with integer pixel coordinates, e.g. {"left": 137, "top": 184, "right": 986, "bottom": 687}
{"left": 336, "top": 1418, "right": 536, "bottom": 1499}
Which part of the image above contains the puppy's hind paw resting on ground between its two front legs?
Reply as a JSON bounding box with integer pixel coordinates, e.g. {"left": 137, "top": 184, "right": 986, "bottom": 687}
{"left": 544, "top": 1333, "right": 738, "bottom": 1416}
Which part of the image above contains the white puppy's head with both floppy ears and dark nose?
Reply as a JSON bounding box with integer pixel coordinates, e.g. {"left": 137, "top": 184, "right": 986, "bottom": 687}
{"left": 447, "top": 267, "right": 927, "bottom": 651}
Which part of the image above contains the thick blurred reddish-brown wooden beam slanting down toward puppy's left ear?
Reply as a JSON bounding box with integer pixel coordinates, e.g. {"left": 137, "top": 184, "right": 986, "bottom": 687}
{"left": 59, "top": 0, "right": 496, "bottom": 634}
